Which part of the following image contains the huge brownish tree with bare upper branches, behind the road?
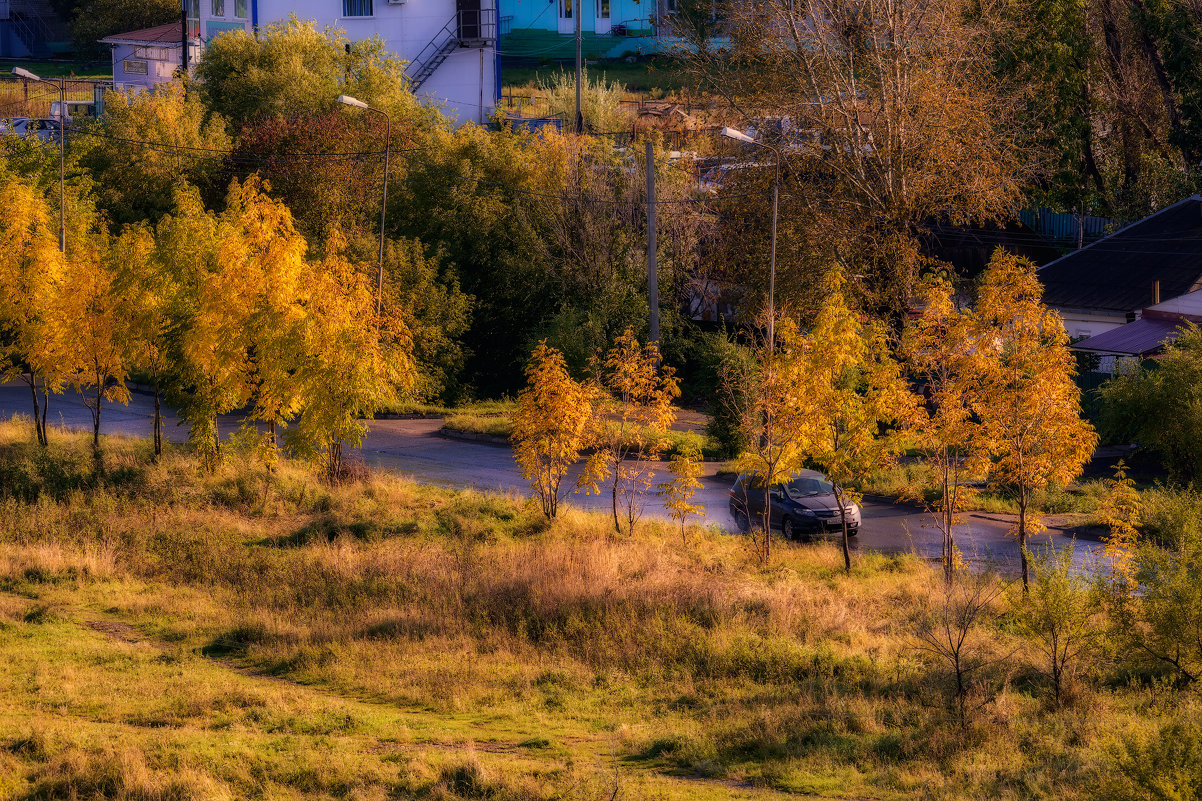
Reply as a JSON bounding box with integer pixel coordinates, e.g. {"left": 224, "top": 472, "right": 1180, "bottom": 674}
{"left": 688, "top": 0, "right": 1022, "bottom": 322}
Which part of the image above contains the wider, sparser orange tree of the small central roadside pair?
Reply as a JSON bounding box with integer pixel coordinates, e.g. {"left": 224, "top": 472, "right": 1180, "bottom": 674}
{"left": 582, "top": 328, "right": 680, "bottom": 534}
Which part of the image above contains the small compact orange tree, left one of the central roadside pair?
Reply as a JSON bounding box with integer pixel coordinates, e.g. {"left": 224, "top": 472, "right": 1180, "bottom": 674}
{"left": 511, "top": 340, "right": 593, "bottom": 520}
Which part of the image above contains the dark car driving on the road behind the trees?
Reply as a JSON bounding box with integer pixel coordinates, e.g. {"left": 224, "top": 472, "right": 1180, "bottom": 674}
{"left": 731, "top": 470, "right": 861, "bottom": 539}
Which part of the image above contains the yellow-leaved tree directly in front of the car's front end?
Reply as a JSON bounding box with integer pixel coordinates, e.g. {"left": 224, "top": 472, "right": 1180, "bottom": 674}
{"left": 802, "top": 274, "right": 916, "bottom": 572}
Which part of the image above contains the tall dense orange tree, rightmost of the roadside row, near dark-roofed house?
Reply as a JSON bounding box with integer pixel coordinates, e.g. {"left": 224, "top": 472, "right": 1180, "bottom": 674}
{"left": 972, "top": 250, "right": 1097, "bottom": 588}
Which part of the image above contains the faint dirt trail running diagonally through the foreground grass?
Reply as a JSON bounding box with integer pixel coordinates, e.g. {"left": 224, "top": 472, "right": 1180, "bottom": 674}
{"left": 73, "top": 609, "right": 807, "bottom": 801}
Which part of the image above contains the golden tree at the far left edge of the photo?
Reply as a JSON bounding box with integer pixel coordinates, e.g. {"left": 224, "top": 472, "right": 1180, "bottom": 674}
{"left": 0, "top": 176, "right": 66, "bottom": 445}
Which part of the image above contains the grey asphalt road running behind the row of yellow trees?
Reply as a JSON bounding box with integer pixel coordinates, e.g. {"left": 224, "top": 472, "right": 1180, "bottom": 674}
{"left": 0, "top": 382, "right": 1097, "bottom": 572}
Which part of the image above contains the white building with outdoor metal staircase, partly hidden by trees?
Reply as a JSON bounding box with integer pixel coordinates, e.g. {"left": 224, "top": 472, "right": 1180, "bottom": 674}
{"left": 180, "top": 0, "right": 499, "bottom": 123}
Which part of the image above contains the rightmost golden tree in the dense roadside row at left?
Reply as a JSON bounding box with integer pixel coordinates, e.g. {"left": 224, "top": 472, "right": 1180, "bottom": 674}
{"left": 285, "top": 231, "right": 417, "bottom": 481}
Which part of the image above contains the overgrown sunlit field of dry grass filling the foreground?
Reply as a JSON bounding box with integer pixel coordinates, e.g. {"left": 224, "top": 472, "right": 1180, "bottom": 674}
{"left": 0, "top": 422, "right": 1200, "bottom": 799}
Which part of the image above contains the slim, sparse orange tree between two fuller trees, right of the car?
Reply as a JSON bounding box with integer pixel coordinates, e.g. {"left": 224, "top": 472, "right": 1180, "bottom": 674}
{"left": 903, "top": 279, "right": 987, "bottom": 581}
